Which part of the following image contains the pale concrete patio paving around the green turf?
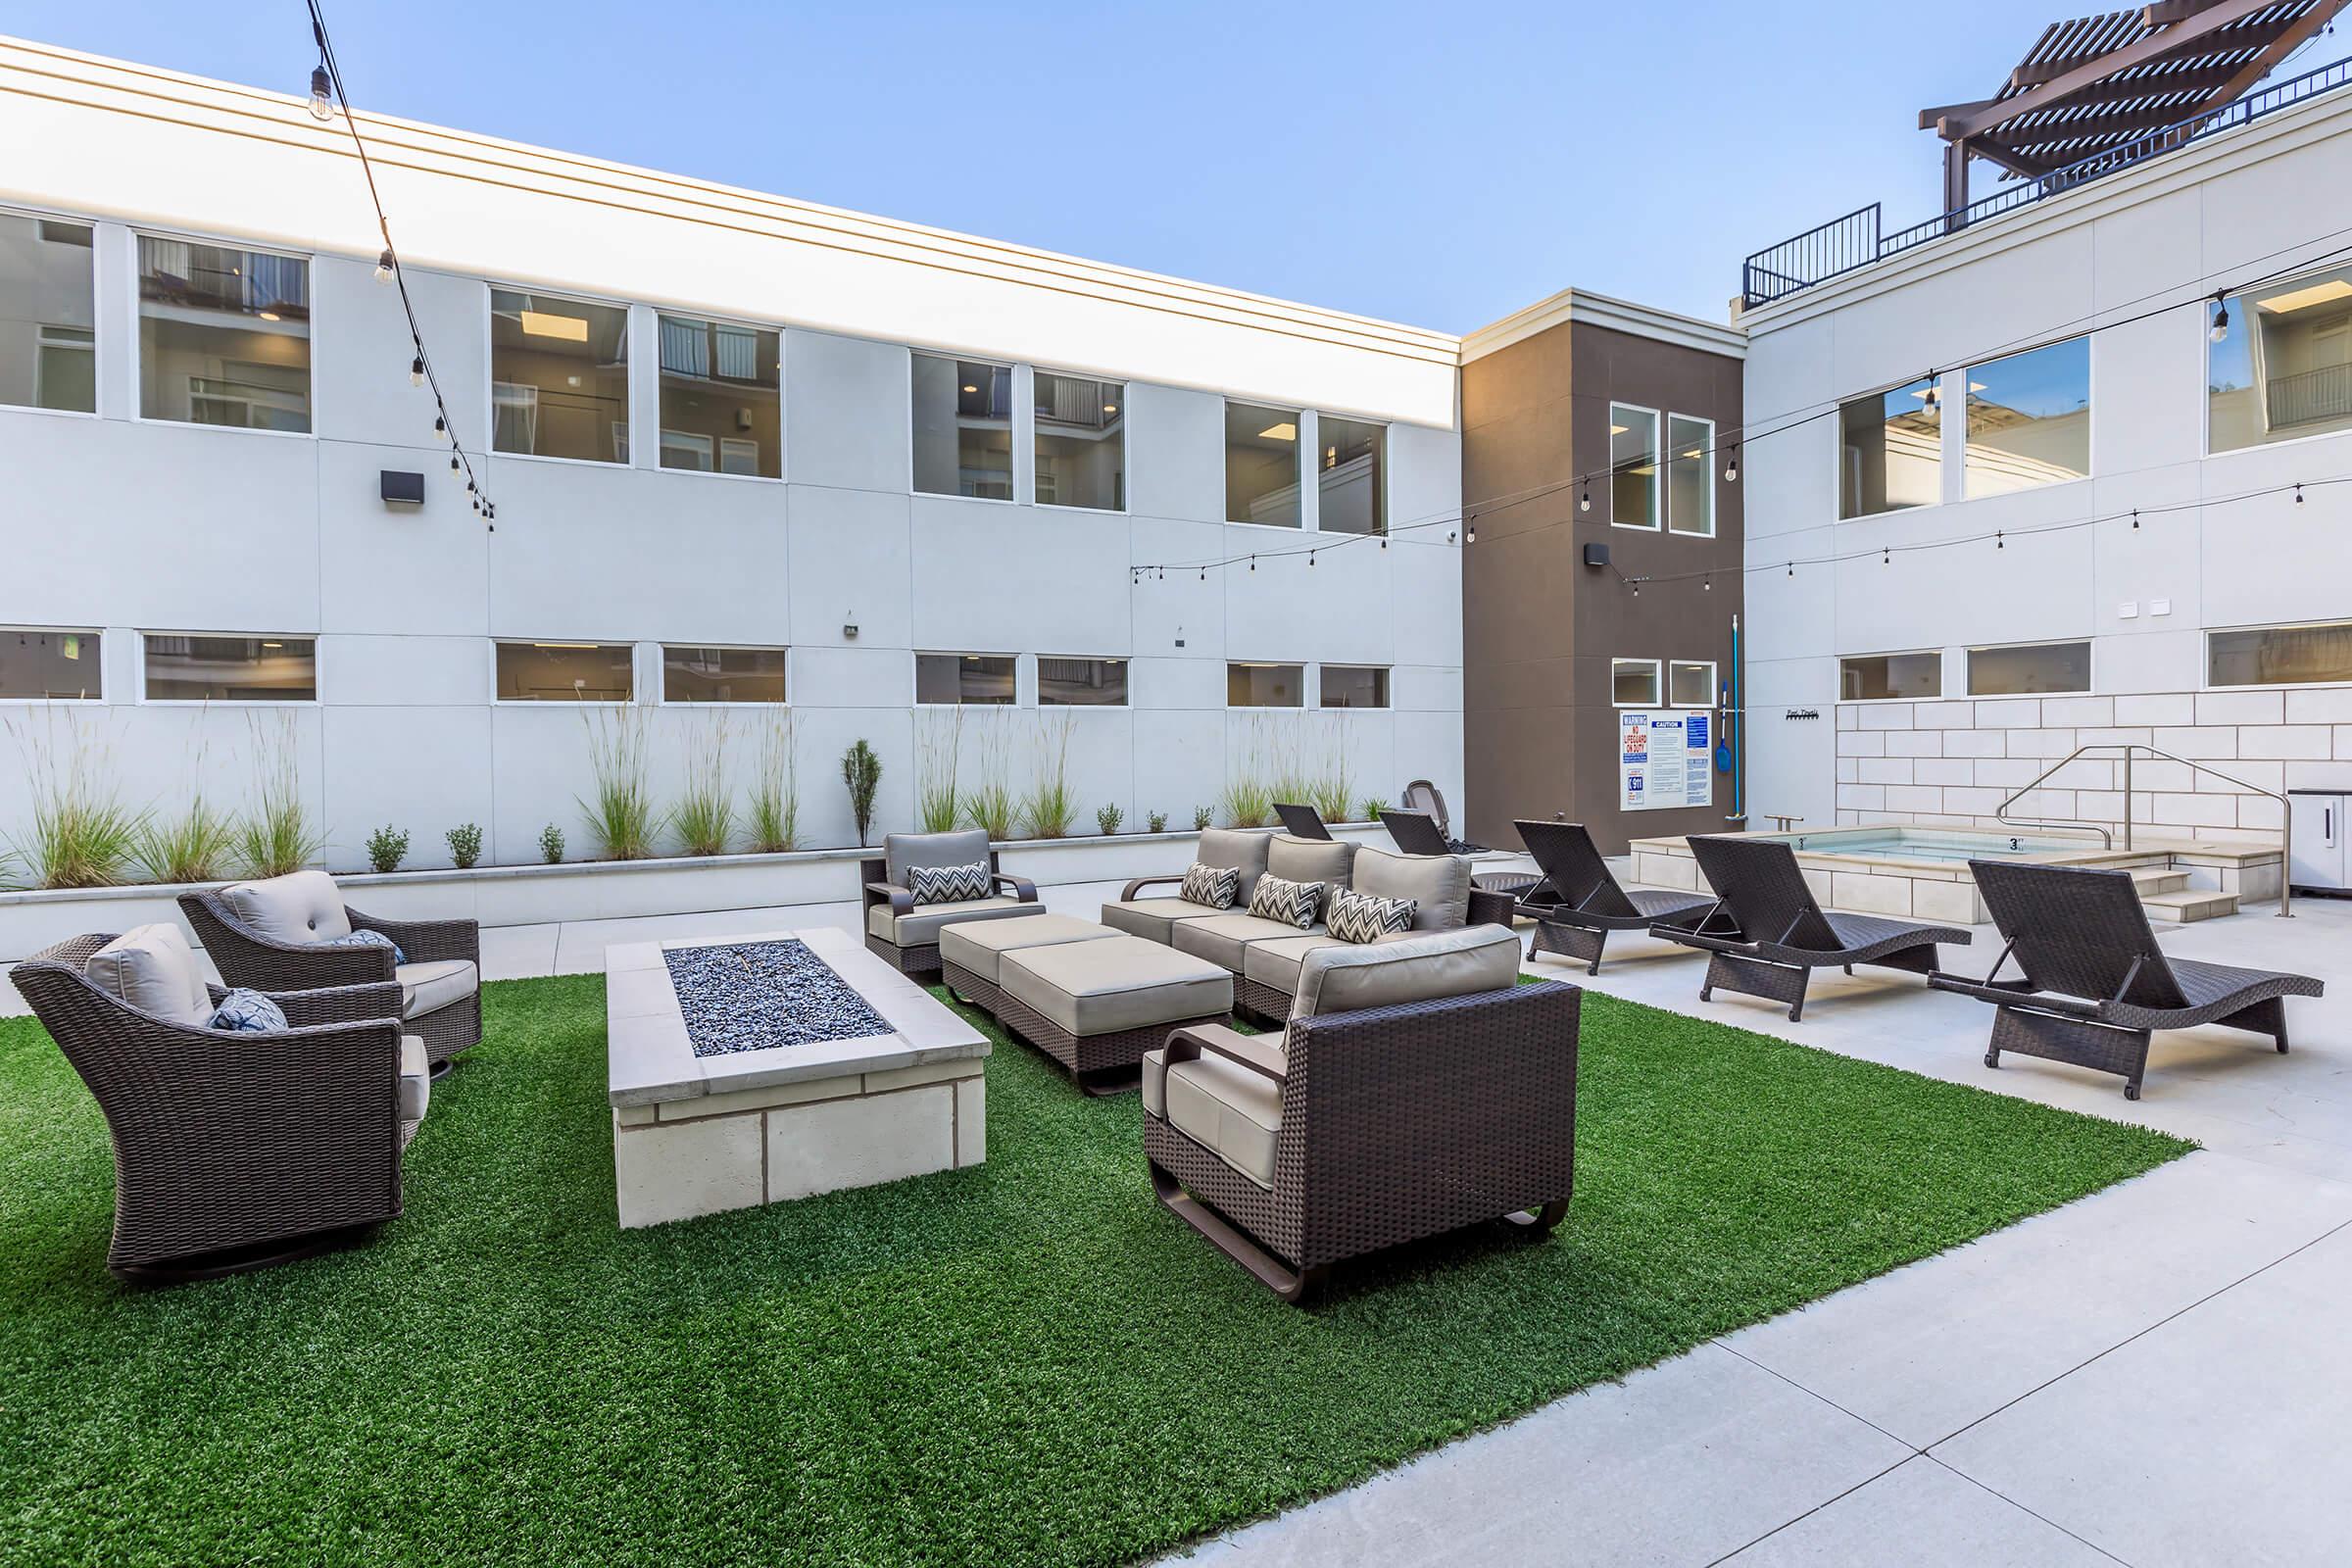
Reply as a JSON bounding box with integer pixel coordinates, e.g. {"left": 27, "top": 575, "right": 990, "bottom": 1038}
{"left": 0, "top": 867, "right": 2352, "bottom": 1568}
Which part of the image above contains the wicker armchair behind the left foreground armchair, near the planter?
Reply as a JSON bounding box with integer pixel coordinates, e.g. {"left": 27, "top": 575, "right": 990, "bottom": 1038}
{"left": 178, "top": 872, "right": 482, "bottom": 1074}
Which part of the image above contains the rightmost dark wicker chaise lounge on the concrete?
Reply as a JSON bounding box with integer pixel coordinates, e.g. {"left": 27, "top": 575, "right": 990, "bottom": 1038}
{"left": 1927, "top": 860, "right": 2322, "bottom": 1101}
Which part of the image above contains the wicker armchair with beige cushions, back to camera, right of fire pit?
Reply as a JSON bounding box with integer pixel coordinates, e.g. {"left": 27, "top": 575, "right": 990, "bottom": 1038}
{"left": 1143, "top": 926, "right": 1583, "bottom": 1302}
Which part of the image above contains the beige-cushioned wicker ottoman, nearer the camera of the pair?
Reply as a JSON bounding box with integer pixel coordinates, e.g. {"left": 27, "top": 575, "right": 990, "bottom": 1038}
{"left": 998, "top": 936, "right": 1233, "bottom": 1093}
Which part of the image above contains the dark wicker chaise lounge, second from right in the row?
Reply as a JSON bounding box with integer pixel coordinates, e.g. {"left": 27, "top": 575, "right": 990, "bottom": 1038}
{"left": 1651, "top": 835, "right": 1969, "bottom": 1022}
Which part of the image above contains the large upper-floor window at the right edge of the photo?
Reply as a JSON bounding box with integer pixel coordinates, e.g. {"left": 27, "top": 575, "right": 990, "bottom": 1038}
{"left": 2206, "top": 266, "right": 2352, "bottom": 452}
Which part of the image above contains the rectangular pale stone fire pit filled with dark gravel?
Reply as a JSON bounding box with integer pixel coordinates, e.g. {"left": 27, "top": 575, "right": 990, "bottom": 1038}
{"left": 605, "top": 929, "right": 988, "bottom": 1230}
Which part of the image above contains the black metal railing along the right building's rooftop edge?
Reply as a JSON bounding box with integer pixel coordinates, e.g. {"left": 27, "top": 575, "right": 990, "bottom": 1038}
{"left": 1740, "top": 59, "right": 2352, "bottom": 308}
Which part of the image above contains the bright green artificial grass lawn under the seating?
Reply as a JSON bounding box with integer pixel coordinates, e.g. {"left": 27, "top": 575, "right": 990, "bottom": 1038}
{"left": 0, "top": 976, "right": 2189, "bottom": 1566}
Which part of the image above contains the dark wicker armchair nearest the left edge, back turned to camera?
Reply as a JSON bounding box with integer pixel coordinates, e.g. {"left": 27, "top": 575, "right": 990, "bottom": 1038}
{"left": 10, "top": 936, "right": 425, "bottom": 1281}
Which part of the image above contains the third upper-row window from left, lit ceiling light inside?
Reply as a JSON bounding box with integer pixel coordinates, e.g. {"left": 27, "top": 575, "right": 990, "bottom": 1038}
{"left": 489, "top": 289, "right": 628, "bottom": 464}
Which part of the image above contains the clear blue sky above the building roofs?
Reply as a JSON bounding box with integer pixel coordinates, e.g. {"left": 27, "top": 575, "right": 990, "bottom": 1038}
{"left": 14, "top": 0, "right": 2154, "bottom": 331}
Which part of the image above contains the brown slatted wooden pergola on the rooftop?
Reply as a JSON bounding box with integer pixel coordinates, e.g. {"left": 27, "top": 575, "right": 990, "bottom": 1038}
{"left": 1919, "top": 0, "right": 2352, "bottom": 212}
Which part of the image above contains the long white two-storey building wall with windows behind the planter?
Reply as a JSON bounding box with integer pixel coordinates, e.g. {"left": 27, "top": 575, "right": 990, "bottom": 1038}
{"left": 0, "top": 40, "right": 1463, "bottom": 870}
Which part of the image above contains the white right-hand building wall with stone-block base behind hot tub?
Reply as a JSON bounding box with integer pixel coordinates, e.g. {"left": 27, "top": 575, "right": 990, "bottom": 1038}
{"left": 1740, "top": 77, "right": 2352, "bottom": 842}
